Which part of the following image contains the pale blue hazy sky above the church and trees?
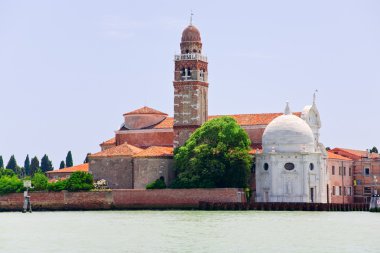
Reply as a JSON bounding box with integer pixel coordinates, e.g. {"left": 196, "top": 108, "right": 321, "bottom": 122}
{"left": 0, "top": 0, "right": 380, "bottom": 167}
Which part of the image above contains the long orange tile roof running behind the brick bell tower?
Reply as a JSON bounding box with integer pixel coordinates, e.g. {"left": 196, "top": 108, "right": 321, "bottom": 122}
{"left": 154, "top": 112, "right": 301, "bottom": 129}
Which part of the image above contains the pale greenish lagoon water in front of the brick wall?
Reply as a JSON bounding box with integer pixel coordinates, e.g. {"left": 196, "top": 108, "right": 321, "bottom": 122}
{"left": 0, "top": 211, "right": 380, "bottom": 253}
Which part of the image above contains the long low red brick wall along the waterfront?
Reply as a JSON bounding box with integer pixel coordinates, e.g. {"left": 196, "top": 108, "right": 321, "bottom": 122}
{"left": 0, "top": 188, "right": 245, "bottom": 211}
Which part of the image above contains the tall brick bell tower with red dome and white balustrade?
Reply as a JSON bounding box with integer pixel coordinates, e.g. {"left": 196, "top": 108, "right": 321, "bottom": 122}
{"left": 173, "top": 22, "right": 208, "bottom": 148}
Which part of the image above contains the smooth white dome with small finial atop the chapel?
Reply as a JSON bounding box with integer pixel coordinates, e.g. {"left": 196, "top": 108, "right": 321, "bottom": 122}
{"left": 263, "top": 107, "right": 315, "bottom": 153}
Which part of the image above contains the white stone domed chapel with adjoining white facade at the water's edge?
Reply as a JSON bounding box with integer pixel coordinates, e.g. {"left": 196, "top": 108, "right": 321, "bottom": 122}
{"left": 256, "top": 98, "right": 327, "bottom": 203}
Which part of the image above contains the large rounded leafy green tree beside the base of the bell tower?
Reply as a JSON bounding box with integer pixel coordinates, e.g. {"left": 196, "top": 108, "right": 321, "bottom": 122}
{"left": 172, "top": 117, "right": 252, "bottom": 188}
